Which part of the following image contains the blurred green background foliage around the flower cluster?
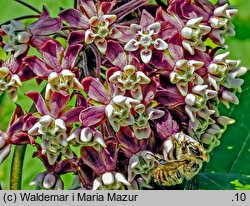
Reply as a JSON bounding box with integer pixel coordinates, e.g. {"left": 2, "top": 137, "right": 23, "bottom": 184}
{"left": 0, "top": 0, "right": 250, "bottom": 189}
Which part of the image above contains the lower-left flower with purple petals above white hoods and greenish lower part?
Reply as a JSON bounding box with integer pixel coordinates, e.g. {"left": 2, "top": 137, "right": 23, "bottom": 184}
{"left": 26, "top": 91, "right": 83, "bottom": 164}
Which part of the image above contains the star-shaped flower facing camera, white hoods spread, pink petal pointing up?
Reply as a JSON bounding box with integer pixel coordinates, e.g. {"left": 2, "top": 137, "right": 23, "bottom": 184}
{"left": 124, "top": 10, "right": 168, "bottom": 64}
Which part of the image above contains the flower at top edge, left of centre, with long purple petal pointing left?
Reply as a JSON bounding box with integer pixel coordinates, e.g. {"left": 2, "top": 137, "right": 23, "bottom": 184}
{"left": 59, "top": 0, "right": 122, "bottom": 53}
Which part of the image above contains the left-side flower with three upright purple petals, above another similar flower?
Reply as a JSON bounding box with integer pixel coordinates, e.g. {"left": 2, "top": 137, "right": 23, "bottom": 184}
{"left": 24, "top": 40, "right": 83, "bottom": 100}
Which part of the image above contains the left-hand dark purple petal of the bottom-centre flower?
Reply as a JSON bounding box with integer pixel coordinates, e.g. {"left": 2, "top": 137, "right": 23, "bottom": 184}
{"left": 81, "top": 147, "right": 106, "bottom": 174}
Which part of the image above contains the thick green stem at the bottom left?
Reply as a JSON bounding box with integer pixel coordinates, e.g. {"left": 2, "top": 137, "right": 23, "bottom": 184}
{"left": 10, "top": 145, "right": 27, "bottom": 190}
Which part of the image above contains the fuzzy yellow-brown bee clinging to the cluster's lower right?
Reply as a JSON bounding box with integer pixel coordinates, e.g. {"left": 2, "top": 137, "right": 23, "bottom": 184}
{"left": 147, "top": 132, "right": 208, "bottom": 186}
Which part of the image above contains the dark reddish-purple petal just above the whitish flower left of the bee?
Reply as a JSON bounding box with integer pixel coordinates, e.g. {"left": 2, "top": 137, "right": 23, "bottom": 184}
{"left": 116, "top": 127, "right": 140, "bottom": 154}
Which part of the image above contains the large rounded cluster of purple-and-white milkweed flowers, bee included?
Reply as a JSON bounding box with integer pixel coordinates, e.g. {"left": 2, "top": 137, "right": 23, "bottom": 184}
{"left": 0, "top": 0, "right": 247, "bottom": 190}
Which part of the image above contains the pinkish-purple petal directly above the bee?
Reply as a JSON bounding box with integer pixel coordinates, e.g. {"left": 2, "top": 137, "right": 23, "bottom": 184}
{"left": 154, "top": 109, "right": 179, "bottom": 140}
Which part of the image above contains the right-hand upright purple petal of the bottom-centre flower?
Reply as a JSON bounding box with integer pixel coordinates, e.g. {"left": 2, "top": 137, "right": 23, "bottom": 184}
{"left": 100, "top": 141, "right": 118, "bottom": 171}
